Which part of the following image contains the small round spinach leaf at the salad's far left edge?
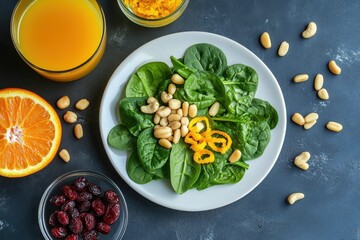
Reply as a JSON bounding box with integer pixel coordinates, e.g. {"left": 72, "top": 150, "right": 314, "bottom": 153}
{"left": 107, "top": 124, "right": 136, "bottom": 150}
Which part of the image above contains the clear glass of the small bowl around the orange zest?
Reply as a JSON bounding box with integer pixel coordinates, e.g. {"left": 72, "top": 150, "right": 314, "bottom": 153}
{"left": 117, "top": 0, "right": 190, "bottom": 28}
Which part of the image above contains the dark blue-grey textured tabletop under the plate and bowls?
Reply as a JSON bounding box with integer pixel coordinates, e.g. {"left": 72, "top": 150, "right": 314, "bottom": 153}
{"left": 0, "top": 0, "right": 360, "bottom": 240}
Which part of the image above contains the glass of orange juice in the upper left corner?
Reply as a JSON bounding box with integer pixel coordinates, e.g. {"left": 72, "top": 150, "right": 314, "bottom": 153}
{"left": 11, "top": 0, "right": 106, "bottom": 82}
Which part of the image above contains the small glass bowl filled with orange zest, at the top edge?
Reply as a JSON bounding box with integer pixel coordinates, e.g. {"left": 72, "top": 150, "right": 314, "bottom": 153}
{"left": 118, "top": 0, "right": 190, "bottom": 28}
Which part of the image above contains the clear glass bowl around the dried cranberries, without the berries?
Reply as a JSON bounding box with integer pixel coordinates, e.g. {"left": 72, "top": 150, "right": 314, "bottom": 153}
{"left": 38, "top": 170, "right": 128, "bottom": 240}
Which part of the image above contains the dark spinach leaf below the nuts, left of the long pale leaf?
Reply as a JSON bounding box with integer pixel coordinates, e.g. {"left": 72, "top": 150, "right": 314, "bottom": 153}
{"left": 137, "top": 128, "right": 171, "bottom": 172}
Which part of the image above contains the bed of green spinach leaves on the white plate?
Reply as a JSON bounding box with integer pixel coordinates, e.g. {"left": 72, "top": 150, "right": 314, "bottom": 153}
{"left": 108, "top": 43, "right": 278, "bottom": 194}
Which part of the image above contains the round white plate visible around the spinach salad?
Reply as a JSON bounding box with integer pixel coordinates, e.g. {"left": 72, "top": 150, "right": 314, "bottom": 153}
{"left": 99, "top": 32, "right": 286, "bottom": 211}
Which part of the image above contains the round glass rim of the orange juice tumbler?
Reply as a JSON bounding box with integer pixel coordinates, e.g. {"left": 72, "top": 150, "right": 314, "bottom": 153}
{"left": 10, "top": 0, "right": 107, "bottom": 74}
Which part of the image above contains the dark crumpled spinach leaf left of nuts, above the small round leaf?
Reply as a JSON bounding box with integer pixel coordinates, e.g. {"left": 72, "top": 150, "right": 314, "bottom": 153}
{"left": 119, "top": 97, "right": 154, "bottom": 137}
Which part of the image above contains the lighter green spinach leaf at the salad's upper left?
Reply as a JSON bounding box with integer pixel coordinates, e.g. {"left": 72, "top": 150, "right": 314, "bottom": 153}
{"left": 125, "top": 62, "right": 171, "bottom": 97}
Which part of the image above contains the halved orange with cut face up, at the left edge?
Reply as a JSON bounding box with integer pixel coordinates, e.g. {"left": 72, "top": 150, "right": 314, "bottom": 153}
{"left": 0, "top": 88, "right": 62, "bottom": 178}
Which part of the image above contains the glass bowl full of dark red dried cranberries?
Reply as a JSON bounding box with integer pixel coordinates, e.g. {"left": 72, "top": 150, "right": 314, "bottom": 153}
{"left": 38, "top": 171, "right": 128, "bottom": 240}
